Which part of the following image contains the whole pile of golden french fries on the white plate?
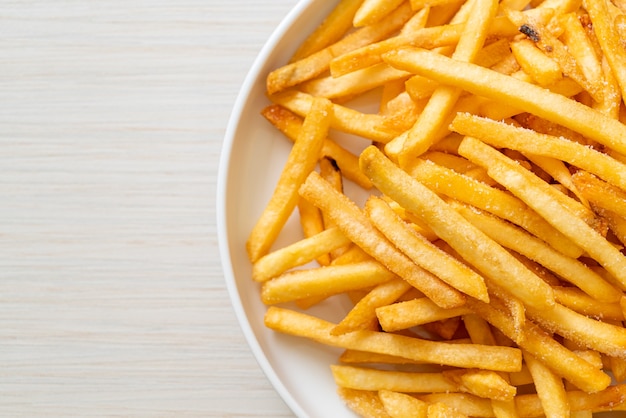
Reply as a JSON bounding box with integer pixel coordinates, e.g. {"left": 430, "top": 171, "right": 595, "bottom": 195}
{"left": 246, "top": 0, "right": 626, "bottom": 418}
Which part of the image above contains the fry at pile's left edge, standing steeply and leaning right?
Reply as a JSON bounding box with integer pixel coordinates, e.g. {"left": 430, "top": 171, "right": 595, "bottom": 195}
{"left": 246, "top": 98, "right": 333, "bottom": 263}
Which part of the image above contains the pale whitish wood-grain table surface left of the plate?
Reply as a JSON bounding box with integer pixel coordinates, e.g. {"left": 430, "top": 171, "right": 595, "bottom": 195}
{"left": 0, "top": 0, "right": 296, "bottom": 417}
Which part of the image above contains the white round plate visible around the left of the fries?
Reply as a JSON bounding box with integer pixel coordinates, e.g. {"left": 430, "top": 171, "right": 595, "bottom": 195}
{"left": 217, "top": 0, "right": 355, "bottom": 418}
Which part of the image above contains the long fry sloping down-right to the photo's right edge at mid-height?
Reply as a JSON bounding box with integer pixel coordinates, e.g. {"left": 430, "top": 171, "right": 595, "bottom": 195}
{"left": 459, "top": 137, "right": 626, "bottom": 286}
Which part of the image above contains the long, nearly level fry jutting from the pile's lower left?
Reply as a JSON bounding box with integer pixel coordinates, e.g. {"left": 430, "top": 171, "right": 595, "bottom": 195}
{"left": 265, "top": 306, "right": 522, "bottom": 372}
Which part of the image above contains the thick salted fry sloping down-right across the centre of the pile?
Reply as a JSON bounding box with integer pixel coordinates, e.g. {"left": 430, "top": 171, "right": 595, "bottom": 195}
{"left": 360, "top": 146, "right": 554, "bottom": 309}
